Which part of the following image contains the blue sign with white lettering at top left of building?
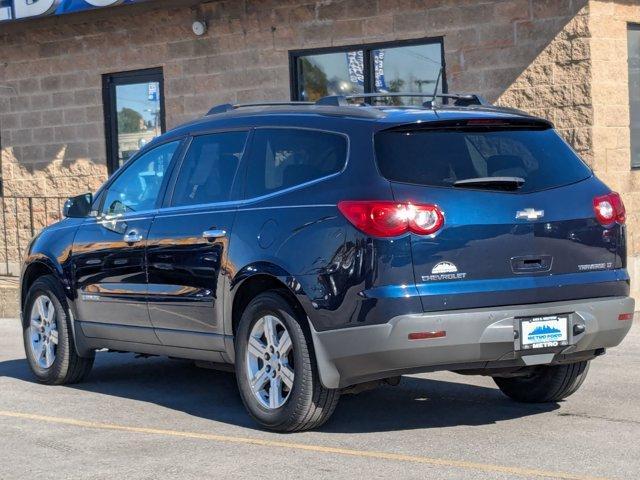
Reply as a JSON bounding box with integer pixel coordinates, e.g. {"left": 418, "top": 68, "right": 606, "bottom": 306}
{"left": 0, "top": 0, "right": 148, "bottom": 22}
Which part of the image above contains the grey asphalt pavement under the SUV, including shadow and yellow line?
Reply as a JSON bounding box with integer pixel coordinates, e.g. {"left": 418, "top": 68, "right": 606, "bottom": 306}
{"left": 0, "top": 319, "right": 640, "bottom": 480}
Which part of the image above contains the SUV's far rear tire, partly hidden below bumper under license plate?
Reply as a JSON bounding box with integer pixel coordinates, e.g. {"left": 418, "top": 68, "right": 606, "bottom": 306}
{"left": 493, "top": 361, "right": 589, "bottom": 403}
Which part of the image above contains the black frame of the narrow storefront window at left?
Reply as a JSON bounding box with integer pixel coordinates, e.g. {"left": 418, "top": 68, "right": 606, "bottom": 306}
{"left": 102, "top": 67, "right": 167, "bottom": 175}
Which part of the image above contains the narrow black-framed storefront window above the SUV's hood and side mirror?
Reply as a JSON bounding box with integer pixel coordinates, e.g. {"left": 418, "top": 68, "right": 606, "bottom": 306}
{"left": 104, "top": 69, "right": 164, "bottom": 172}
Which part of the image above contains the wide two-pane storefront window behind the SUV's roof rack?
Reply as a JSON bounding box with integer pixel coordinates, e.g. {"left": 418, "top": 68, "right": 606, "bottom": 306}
{"left": 291, "top": 39, "right": 445, "bottom": 105}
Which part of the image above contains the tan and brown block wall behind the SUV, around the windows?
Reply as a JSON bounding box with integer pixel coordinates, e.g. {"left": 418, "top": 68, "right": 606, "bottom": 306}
{"left": 0, "top": 0, "right": 628, "bottom": 284}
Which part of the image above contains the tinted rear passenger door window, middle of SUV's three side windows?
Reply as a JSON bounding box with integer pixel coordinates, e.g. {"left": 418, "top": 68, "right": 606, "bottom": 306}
{"left": 171, "top": 132, "right": 247, "bottom": 206}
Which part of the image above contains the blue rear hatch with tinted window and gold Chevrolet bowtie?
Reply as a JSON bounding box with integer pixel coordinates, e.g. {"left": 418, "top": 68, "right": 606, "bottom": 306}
{"left": 375, "top": 119, "right": 628, "bottom": 311}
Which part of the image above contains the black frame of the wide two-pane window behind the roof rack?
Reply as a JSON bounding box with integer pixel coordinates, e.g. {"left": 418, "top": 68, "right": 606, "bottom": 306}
{"left": 289, "top": 36, "right": 449, "bottom": 101}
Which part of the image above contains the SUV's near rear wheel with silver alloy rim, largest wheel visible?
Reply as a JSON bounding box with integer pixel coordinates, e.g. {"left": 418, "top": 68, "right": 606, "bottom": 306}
{"left": 235, "top": 291, "right": 340, "bottom": 432}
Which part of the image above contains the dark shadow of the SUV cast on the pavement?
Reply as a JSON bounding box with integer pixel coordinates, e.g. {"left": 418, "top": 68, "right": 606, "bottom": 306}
{"left": 0, "top": 353, "right": 559, "bottom": 433}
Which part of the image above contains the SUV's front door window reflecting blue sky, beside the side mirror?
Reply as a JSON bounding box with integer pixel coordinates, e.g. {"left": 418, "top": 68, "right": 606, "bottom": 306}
{"left": 102, "top": 141, "right": 180, "bottom": 215}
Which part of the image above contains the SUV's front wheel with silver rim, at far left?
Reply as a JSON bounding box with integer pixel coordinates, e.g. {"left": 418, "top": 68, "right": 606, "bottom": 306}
{"left": 22, "top": 275, "right": 93, "bottom": 385}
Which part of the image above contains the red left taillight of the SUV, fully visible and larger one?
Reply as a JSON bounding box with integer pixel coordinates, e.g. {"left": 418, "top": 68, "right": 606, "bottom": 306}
{"left": 338, "top": 200, "right": 444, "bottom": 237}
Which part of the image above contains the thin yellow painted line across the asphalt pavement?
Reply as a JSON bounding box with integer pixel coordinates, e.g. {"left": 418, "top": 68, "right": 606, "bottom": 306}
{"left": 0, "top": 410, "right": 605, "bottom": 480}
